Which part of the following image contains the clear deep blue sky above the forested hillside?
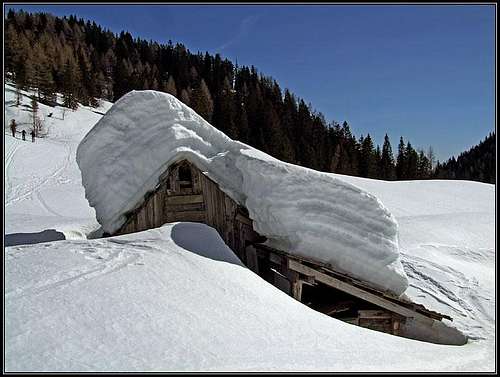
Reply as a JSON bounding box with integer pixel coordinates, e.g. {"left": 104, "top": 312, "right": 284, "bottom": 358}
{"left": 4, "top": 4, "right": 496, "bottom": 161}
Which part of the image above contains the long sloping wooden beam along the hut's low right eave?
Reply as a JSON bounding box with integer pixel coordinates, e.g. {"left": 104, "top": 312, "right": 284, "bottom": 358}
{"left": 288, "top": 259, "right": 434, "bottom": 324}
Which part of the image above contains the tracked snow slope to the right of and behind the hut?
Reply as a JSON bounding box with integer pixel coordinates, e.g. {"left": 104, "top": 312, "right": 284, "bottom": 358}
{"left": 334, "top": 176, "right": 496, "bottom": 339}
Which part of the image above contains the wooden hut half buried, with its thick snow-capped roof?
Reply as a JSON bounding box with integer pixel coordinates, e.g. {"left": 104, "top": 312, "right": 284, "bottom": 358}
{"left": 77, "top": 91, "right": 466, "bottom": 344}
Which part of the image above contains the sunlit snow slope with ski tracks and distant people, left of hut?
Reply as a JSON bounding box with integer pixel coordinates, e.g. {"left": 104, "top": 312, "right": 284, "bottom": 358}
{"left": 4, "top": 85, "right": 112, "bottom": 241}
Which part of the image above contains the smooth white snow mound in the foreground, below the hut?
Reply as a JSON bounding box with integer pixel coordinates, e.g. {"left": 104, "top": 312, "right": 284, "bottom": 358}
{"left": 5, "top": 223, "right": 493, "bottom": 372}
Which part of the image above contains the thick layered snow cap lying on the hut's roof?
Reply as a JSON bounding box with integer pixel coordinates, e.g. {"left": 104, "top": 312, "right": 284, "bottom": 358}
{"left": 76, "top": 90, "right": 408, "bottom": 295}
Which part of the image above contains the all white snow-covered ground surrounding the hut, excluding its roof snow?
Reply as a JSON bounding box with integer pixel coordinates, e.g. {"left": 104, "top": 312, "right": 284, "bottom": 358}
{"left": 4, "top": 86, "right": 496, "bottom": 372}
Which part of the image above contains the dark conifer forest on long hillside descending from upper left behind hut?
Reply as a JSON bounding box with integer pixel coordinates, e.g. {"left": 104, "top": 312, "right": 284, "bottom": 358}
{"left": 4, "top": 10, "right": 494, "bottom": 180}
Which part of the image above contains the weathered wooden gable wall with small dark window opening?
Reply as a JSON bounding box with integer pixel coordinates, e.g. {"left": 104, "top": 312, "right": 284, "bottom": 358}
{"left": 116, "top": 161, "right": 261, "bottom": 263}
